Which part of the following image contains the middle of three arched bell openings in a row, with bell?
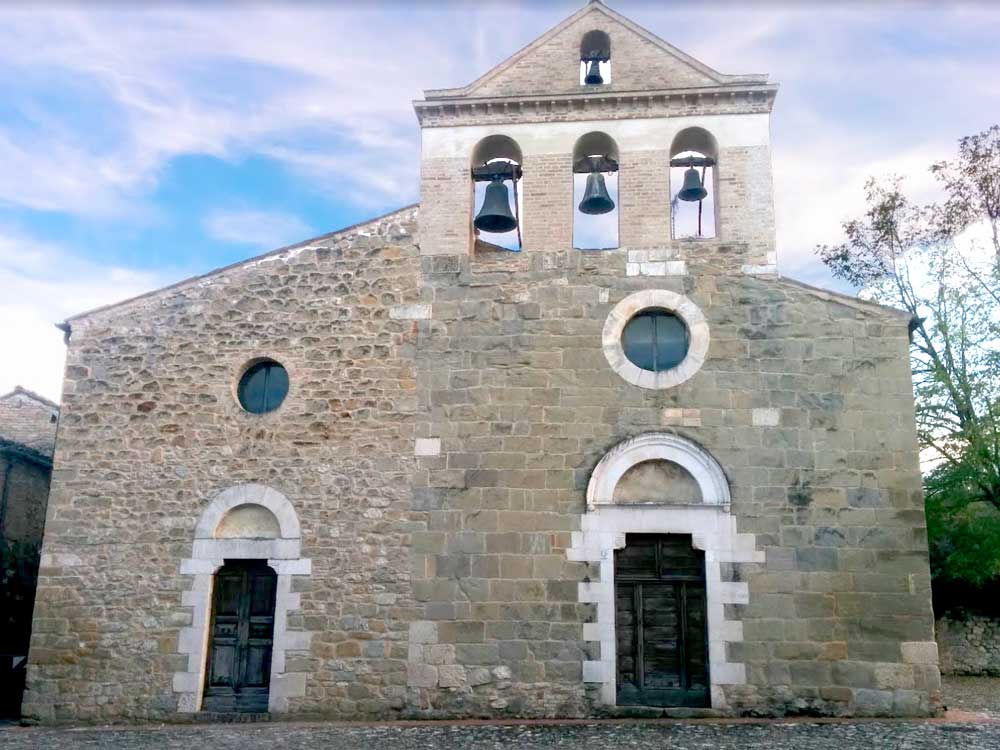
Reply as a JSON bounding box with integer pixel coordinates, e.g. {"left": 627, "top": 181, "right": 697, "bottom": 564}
{"left": 573, "top": 131, "right": 620, "bottom": 250}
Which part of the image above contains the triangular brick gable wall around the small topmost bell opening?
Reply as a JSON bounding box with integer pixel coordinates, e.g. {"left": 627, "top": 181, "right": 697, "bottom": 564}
{"left": 470, "top": 10, "right": 717, "bottom": 96}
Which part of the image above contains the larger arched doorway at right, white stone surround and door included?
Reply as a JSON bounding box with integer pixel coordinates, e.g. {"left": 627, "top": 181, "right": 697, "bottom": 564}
{"left": 567, "top": 432, "right": 764, "bottom": 708}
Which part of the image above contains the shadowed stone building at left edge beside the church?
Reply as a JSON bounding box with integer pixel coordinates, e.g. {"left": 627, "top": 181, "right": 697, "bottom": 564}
{"left": 0, "top": 386, "right": 59, "bottom": 717}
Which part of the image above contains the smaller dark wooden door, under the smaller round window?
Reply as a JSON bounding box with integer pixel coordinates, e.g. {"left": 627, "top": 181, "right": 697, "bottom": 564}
{"left": 203, "top": 560, "right": 278, "bottom": 713}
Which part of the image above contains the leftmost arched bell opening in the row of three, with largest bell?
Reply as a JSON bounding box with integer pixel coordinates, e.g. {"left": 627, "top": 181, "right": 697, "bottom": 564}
{"left": 472, "top": 135, "right": 524, "bottom": 251}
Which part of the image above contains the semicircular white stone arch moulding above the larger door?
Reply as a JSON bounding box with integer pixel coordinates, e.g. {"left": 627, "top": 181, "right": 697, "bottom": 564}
{"left": 587, "top": 432, "right": 732, "bottom": 511}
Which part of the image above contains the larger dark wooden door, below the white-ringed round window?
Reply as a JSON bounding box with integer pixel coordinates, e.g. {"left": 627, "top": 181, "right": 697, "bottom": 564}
{"left": 615, "top": 534, "right": 711, "bottom": 707}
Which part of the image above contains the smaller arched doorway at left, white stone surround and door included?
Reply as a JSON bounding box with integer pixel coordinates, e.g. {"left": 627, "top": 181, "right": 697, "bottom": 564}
{"left": 173, "top": 484, "right": 312, "bottom": 713}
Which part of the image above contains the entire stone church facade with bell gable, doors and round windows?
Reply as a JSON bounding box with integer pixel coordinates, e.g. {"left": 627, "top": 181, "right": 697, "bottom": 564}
{"left": 25, "top": 2, "right": 940, "bottom": 721}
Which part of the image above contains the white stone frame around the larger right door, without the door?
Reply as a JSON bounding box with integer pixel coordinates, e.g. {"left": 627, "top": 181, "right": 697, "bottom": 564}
{"left": 566, "top": 433, "right": 764, "bottom": 709}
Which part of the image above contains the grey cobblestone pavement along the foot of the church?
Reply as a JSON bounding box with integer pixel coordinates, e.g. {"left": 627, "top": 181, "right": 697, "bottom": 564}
{"left": 0, "top": 721, "right": 1000, "bottom": 750}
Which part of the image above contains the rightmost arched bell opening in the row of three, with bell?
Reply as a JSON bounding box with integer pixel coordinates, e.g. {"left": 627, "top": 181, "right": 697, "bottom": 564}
{"left": 670, "top": 127, "right": 719, "bottom": 239}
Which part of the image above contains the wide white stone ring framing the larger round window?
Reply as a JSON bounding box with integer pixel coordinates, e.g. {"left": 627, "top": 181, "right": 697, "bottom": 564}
{"left": 601, "top": 289, "right": 711, "bottom": 390}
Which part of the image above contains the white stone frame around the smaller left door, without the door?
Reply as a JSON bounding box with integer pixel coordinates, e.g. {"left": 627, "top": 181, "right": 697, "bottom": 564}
{"left": 173, "top": 484, "right": 312, "bottom": 713}
